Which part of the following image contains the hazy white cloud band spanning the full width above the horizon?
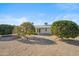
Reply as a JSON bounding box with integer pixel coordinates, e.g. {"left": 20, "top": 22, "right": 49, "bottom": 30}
{"left": 0, "top": 14, "right": 79, "bottom": 25}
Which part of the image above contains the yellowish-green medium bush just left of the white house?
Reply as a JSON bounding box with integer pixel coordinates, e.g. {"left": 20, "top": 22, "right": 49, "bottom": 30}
{"left": 13, "top": 22, "right": 35, "bottom": 36}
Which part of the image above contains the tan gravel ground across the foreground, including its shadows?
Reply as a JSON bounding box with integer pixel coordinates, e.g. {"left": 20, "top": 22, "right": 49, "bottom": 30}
{"left": 0, "top": 36, "right": 79, "bottom": 56}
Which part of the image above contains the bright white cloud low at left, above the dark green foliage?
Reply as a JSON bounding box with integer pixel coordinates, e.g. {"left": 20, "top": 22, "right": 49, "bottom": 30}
{"left": 0, "top": 15, "right": 29, "bottom": 25}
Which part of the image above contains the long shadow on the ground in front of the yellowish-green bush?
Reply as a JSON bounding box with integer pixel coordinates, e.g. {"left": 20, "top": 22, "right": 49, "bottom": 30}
{"left": 18, "top": 37, "right": 56, "bottom": 45}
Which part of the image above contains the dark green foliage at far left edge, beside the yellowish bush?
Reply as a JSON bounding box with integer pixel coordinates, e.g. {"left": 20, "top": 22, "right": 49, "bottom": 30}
{"left": 0, "top": 24, "right": 14, "bottom": 35}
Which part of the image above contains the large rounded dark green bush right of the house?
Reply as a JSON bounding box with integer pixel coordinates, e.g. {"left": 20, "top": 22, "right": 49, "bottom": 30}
{"left": 51, "top": 20, "right": 79, "bottom": 38}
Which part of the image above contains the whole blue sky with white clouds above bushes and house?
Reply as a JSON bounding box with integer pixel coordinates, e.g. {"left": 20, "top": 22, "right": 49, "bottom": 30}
{"left": 0, "top": 3, "right": 79, "bottom": 25}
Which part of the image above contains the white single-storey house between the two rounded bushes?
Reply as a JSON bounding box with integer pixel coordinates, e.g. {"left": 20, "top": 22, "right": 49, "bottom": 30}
{"left": 35, "top": 25, "right": 51, "bottom": 34}
